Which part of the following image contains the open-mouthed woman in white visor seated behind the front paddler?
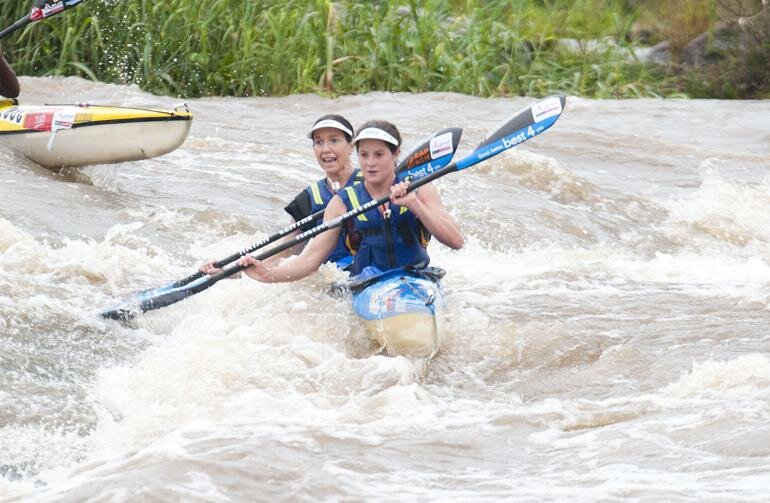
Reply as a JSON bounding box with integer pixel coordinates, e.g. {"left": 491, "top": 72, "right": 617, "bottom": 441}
{"left": 199, "top": 114, "right": 363, "bottom": 274}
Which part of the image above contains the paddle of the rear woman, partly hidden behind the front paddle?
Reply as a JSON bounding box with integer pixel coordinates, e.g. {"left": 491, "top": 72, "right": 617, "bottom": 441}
{"left": 100, "top": 127, "right": 463, "bottom": 320}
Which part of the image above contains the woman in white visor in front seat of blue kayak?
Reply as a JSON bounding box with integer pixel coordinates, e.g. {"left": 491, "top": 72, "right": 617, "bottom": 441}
{"left": 238, "top": 121, "right": 463, "bottom": 283}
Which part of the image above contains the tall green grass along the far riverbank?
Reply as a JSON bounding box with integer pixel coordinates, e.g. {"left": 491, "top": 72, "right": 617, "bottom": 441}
{"left": 0, "top": 0, "right": 764, "bottom": 98}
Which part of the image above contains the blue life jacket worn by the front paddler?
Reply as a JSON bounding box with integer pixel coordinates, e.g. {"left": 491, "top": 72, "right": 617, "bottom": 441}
{"left": 338, "top": 183, "right": 430, "bottom": 274}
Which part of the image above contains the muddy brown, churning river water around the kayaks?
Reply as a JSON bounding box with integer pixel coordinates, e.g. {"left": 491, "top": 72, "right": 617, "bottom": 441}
{"left": 0, "top": 77, "right": 770, "bottom": 502}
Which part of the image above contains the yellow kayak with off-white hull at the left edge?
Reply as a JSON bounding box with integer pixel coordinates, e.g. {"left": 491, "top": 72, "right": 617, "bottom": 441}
{"left": 0, "top": 100, "right": 192, "bottom": 168}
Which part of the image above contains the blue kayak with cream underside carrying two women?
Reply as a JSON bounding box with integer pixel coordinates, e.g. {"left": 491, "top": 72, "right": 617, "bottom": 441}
{"left": 349, "top": 267, "right": 445, "bottom": 357}
